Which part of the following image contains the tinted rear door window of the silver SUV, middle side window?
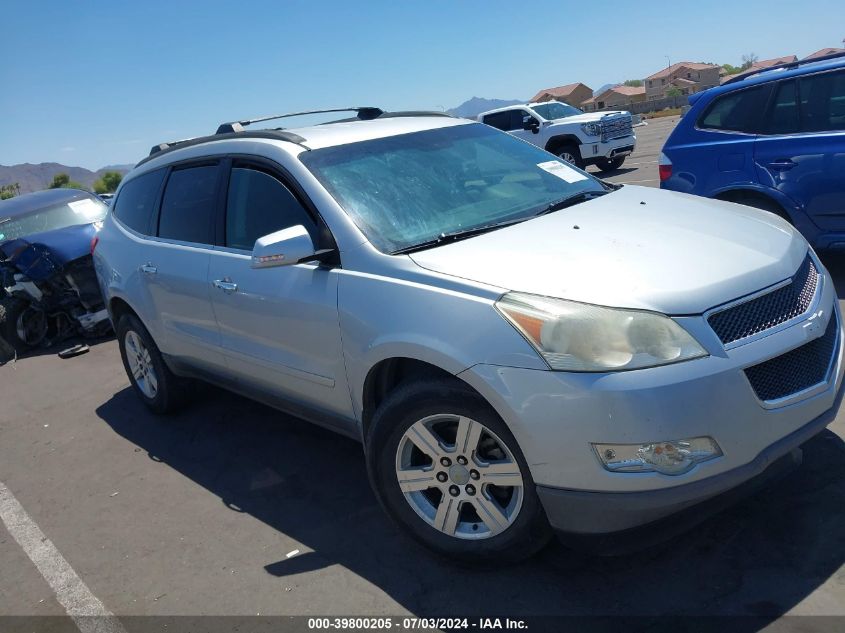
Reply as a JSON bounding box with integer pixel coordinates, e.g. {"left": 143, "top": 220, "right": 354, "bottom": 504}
{"left": 158, "top": 165, "right": 220, "bottom": 244}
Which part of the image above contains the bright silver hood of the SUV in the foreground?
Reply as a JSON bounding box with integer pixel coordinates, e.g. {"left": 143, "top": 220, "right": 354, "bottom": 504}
{"left": 410, "top": 185, "right": 807, "bottom": 315}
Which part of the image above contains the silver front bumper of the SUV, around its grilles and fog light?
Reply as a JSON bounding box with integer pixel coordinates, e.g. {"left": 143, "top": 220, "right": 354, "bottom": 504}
{"left": 460, "top": 262, "right": 843, "bottom": 533}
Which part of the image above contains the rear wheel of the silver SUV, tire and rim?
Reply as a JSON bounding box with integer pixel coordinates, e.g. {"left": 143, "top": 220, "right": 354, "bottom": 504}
{"left": 115, "top": 314, "right": 185, "bottom": 414}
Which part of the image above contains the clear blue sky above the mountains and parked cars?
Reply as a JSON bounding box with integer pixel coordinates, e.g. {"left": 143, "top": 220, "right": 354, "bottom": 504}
{"left": 0, "top": 0, "right": 845, "bottom": 169}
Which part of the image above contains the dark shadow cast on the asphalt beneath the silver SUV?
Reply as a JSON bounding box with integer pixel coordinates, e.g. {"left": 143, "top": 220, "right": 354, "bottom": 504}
{"left": 97, "top": 380, "right": 845, "bottom": 616}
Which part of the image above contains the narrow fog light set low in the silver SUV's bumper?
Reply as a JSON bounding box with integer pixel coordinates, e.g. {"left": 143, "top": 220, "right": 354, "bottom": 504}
{"left": 593, "top": 437, "right": 722, "bottom": 475}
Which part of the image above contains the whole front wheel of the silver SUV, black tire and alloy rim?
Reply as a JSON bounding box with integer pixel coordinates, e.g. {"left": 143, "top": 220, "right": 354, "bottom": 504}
{"left": 366, "top": 381, "right": 551, "bottom": 564}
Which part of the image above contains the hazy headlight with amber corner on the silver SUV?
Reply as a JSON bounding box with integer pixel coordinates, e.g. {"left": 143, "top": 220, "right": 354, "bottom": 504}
{"left": 496, "top": 292, "right": 707, "bottom": 372}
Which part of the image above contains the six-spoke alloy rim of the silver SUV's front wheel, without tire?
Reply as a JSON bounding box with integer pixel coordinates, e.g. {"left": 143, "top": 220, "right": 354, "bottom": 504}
{"left": 396, "top": 414, "right": 524, "bottom": 539}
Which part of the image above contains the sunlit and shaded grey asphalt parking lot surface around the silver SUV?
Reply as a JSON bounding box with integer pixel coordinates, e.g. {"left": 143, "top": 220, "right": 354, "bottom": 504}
{"left": 0, "top": 117, "right": 845, "bottom": 620}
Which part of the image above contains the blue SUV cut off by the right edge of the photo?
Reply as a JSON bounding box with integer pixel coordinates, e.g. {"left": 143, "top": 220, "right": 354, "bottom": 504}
{"left": 658, "top": 53, "right": 845, "bottom": 249}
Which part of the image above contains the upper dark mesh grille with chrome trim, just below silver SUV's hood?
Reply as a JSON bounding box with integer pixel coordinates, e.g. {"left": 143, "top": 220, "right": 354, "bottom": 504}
{"left": 707, "top": 256, "right": 819, "bottom": 345}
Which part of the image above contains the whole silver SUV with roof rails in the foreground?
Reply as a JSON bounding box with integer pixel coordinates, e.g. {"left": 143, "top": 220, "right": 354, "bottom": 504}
{"left": 95, "top": 108, "right": 842, "bottom": 561}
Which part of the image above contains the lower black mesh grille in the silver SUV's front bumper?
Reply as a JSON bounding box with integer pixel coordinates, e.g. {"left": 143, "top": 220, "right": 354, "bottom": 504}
{"left": 745, "top": 314, "right": 839, "bottom": 402}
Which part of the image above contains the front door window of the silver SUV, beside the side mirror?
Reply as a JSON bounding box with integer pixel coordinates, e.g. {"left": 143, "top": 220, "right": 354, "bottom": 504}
{"left": 226, "top": 167, "right": 317, "bottom": 251}
